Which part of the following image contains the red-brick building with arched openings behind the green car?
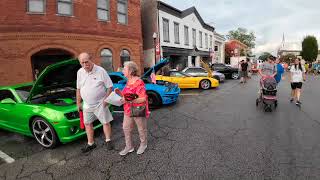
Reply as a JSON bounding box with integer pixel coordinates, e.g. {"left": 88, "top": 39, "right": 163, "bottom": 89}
{"left": 0, "top": 0, "right": 143, "bottom": 85}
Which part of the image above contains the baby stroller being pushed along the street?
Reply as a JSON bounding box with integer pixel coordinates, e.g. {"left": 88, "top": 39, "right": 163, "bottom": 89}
{"left": 256, "top": 76, "right": 278, "bottom": 112}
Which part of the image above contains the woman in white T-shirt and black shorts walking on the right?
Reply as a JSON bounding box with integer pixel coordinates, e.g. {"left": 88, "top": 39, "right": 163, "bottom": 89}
{"left": 290, "top": 58, "right": 306, "bottom": 106}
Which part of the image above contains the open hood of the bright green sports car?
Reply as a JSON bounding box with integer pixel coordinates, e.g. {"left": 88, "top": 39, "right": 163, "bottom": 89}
{"left": 27, "top": 59, "right": 81, "bottom": 102}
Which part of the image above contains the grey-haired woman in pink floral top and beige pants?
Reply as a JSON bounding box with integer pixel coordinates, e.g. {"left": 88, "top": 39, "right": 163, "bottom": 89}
{"left": 119, "top": 61, "right": 150, "bottom": 156}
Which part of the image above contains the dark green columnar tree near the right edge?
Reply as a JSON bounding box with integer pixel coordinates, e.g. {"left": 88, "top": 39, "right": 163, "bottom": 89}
{"left": 301, "top": 36, "right": 318, "bottom": 62}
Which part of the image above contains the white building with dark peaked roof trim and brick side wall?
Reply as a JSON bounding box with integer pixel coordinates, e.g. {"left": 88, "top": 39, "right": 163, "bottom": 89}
{"left": 142, "top": 0, "right": 219, "bottom": 70}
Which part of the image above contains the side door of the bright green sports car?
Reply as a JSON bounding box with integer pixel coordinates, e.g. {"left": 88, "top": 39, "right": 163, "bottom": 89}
{"left": 0, "top": 89, "right": 23, "bottom": 131}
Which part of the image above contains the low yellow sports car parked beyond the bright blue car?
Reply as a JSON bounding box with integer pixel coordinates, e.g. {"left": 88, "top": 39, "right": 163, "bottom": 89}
{"left": 156, "top": 71, "right": 219, "bottom": 89}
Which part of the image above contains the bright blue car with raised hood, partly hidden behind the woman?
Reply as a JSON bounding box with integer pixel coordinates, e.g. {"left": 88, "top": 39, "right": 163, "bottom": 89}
{"left": 109, "top": 59, "right": 181, "bottom": 107}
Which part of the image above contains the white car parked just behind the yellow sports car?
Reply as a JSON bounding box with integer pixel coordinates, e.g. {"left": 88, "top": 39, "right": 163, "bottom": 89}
{"left": 182, "top": 67, "right": 226, "bottom": 82}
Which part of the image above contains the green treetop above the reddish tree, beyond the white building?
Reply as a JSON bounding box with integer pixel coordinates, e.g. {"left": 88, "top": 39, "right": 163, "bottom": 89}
{"left": 227, "top": 28, "right": 256, "bottom": 49}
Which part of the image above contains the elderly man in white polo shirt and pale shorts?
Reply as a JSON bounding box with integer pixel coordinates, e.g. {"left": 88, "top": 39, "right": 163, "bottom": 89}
{"left": 77, "top": 53, "right": 113, "bottom": 153}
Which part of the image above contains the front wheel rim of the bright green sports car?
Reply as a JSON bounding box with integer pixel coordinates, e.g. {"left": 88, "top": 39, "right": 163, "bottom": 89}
{"left": 32, "top": 120, "right": 53, "bottom": 147}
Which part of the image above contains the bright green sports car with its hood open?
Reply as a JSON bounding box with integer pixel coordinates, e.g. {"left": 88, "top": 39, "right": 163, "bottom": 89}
{"left": 0, "top": 59, "right": 101, "bottom": 148}
